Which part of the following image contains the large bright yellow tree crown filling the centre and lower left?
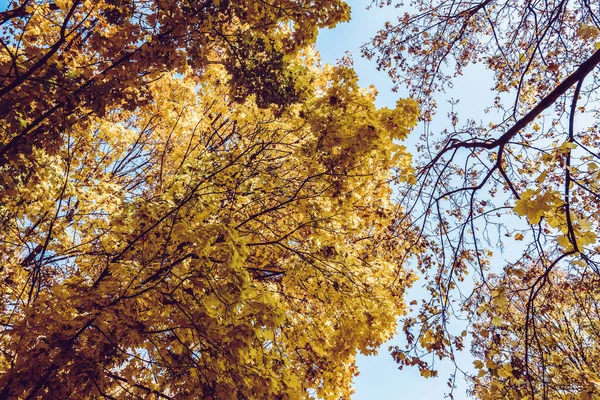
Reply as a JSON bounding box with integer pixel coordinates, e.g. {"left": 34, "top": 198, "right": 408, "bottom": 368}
{"left": 0, "top": 39, "right": 417, "bottom": 399}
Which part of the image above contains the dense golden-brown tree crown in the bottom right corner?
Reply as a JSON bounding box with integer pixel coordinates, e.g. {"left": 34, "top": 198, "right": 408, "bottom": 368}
{"left": 472, "top": 271, "right": 600, "bottom": 400}
